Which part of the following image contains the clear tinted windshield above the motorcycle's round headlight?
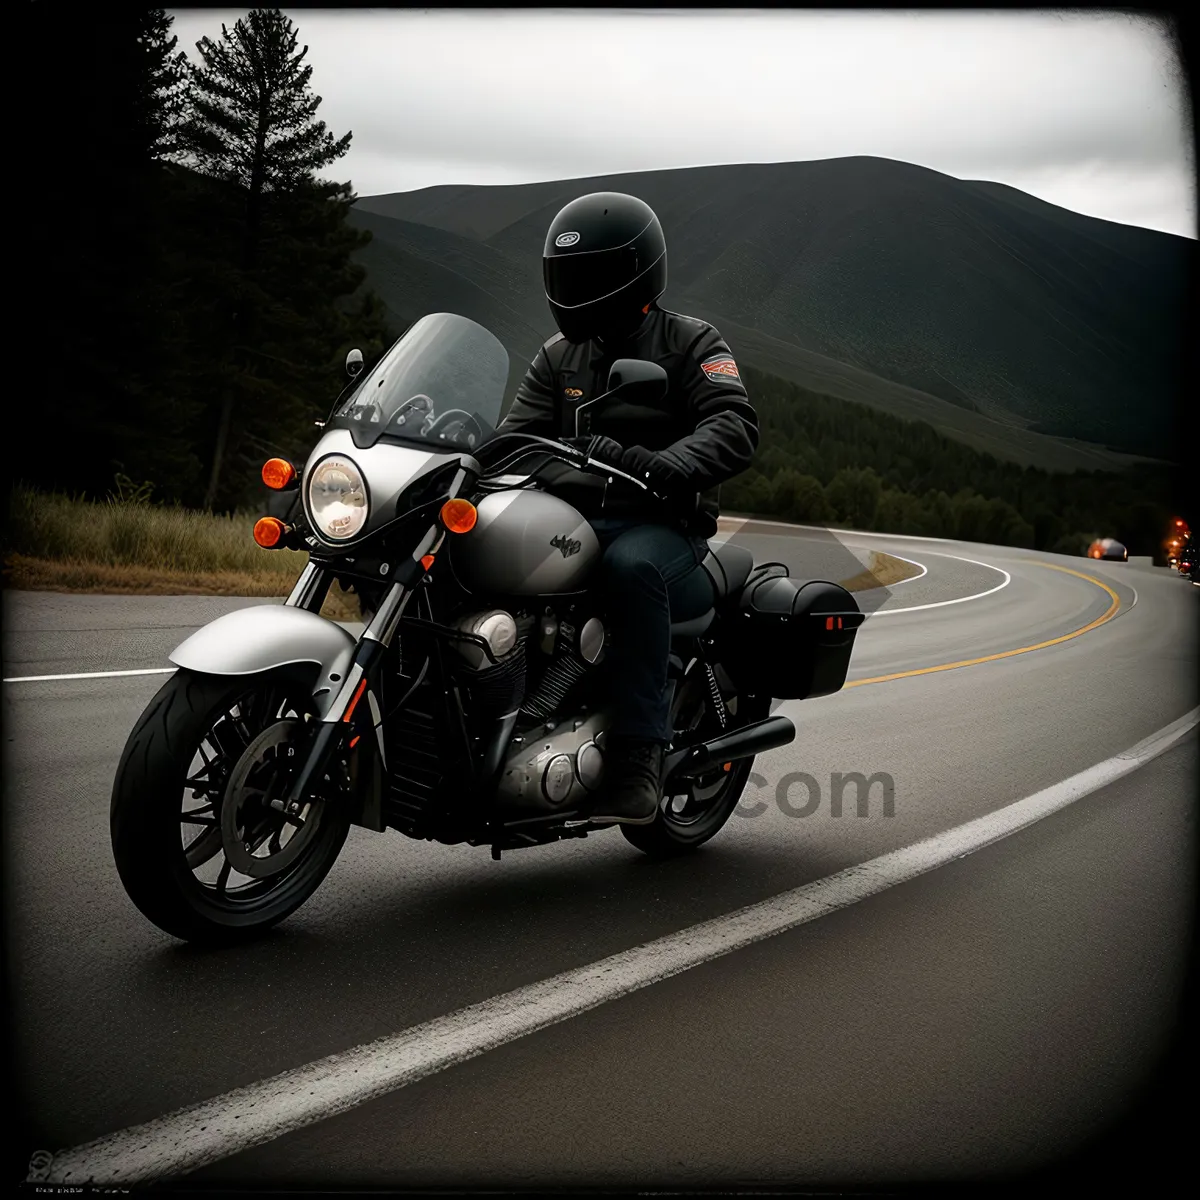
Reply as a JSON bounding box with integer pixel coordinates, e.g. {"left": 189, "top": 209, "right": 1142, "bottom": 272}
{"left": 330, "top": 312, "right": 509, "bottom": 450}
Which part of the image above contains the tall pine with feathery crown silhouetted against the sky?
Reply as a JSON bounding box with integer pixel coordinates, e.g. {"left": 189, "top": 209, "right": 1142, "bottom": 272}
{"left": 180, "top": 8, "right": 354, "bottom": 506}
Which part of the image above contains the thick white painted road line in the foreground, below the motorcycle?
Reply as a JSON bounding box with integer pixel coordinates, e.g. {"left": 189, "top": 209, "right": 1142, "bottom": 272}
{"left": 38, "top": 707, "right": 1200, "bottom": 1186}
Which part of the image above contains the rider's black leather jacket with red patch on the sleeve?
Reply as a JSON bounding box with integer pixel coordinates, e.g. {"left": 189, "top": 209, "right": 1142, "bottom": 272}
{"left": 500, "top": 305, "right": 758, "bottom": 538}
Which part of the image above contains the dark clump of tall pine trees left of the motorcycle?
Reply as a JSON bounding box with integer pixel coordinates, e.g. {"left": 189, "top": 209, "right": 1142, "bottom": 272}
{"left": 20, "top": 2, "right": 389, "bottom": 509}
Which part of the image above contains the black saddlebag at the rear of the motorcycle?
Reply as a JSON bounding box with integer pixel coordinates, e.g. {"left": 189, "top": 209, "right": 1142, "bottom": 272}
{"left": 722, "top": 563, "right": 864, "bottom": 700}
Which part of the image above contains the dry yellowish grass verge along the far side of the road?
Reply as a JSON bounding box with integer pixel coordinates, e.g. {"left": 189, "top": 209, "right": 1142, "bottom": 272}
{"left": 4, "top": 488, "right": 917, "bottom": 620}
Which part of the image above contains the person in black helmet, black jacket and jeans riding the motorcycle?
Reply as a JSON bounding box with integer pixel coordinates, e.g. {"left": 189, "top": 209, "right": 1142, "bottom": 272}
{"left": 500, "top": 192, "right": 758, "bottom": 824}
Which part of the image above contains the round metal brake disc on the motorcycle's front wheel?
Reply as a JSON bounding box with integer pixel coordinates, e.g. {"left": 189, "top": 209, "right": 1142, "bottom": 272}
{"left": 221, "top": 716, "right": 320, "bottom": 880}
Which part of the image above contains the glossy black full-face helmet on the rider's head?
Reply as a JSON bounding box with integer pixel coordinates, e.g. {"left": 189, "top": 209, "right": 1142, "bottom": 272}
{"left": 541, "top": 192, "right": 667, "bottom": 342}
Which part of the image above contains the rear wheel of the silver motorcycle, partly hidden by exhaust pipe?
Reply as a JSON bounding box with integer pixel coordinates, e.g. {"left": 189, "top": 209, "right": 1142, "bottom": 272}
{"left": 620, "top": 661, "right": 763, "bottom": 858}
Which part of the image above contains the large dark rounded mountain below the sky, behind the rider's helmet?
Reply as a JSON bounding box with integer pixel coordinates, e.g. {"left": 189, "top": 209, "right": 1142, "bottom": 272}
{"left": 356, "top": 157, "right": 1194, "bottom": 461}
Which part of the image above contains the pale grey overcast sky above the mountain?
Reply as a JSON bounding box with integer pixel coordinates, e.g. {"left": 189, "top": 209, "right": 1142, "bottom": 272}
{"left": 166, "top": 8, "right": 1196, "bottom": 238}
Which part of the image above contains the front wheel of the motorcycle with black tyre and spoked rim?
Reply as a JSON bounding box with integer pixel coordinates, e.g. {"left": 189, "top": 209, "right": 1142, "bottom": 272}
{"left": 109, "top": 668, "right": 350, "bottom": 943}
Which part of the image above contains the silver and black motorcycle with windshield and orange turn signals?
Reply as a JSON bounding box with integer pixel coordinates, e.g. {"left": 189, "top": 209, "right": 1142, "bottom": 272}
{"left": 110, "top": 313, "right": 863, "bottom": 943}
